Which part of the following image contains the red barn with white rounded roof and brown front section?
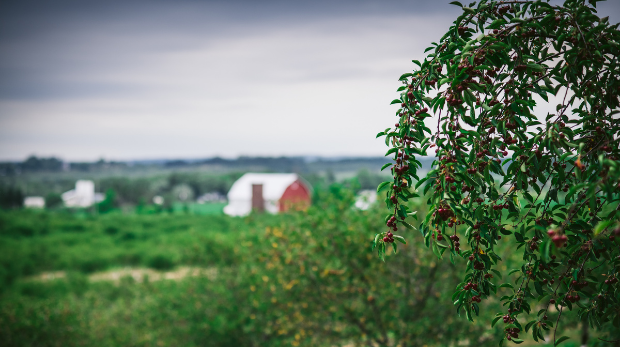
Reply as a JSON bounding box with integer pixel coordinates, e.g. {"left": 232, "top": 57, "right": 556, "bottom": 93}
{"left": 224, "top": 173, "right": 311, "bottom": 216}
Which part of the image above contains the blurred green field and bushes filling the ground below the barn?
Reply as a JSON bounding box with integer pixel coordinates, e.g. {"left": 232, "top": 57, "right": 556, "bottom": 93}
{"left": 0, "top": 184, "right": 600, "bottom": 346}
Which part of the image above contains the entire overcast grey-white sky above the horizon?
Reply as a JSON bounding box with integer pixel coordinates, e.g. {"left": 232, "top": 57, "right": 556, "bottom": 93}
{"left": 0, "top": 0, "right": 620, "bottom": 160}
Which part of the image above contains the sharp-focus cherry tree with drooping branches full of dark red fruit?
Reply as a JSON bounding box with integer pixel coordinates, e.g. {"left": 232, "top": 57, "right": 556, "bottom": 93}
{"left": 374, "top": 0, "right": 620, "bottom": 345}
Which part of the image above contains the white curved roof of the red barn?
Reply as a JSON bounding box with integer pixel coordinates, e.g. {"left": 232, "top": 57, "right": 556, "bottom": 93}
{"left": 224, "top": 173, "right": 310, "bottom": 216}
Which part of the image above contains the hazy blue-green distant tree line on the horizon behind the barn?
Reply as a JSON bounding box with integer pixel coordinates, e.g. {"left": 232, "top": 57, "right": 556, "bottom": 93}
{"left": 0, "top": 156, "right": 398, "bottom": 209}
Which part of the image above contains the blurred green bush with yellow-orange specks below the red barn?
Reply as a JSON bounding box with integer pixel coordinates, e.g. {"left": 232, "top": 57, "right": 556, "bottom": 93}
{"left": 249, "top": 189, "right": 499, "bottom": 346}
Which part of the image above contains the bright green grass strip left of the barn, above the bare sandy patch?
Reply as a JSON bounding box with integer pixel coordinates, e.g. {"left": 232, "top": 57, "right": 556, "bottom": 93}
{"left": 0, "top": 210, "right": 271, "bottom": 289}
